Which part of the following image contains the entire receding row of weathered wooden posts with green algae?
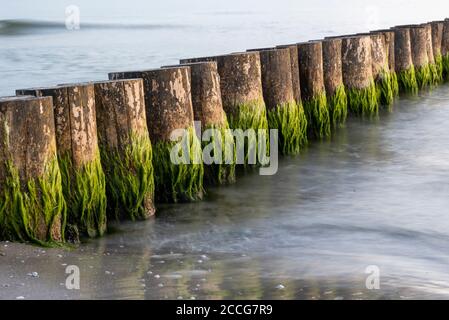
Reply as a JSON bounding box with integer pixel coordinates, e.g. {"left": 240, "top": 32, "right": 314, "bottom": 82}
{"left": 0, "top": 19, "right": 449, "bottom": 245}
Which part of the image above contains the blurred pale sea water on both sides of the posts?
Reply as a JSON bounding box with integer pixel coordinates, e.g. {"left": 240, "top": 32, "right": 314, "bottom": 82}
{"left": 0, "top": 0, "right": 449, "bottom": 299}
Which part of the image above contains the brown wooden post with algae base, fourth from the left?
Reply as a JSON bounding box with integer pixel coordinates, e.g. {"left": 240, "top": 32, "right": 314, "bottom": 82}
{"left": 109, "top": 67, "right": 204, "bottom": 202}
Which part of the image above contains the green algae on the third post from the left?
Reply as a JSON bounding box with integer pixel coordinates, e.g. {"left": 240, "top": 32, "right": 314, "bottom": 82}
{"left": 101, "top": 134, "right": 154, "bottom": 220}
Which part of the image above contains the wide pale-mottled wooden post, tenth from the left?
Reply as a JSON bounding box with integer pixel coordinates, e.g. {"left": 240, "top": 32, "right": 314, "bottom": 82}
{"left": 342, "top": 36, "right": 379, "bottom": 117}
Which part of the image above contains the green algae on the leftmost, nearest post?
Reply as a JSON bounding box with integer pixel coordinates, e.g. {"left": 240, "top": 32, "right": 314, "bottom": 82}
{"left": 0, "top": 157, "right": 67, "bottom": 245}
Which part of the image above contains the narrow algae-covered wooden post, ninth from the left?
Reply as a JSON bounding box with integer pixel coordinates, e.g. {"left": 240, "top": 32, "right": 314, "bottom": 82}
{"left": 322, "top": 38, "right": 348, "bottom": 128}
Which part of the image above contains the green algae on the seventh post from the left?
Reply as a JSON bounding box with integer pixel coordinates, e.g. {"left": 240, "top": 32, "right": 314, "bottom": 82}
{"left": 268, "top": 102, "right": 307, "bottom": 155}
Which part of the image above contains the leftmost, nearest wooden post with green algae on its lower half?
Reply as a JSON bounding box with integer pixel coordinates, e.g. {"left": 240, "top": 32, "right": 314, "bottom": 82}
{"left": 0, "top": 96, "right": 66, "bottom": 244}
